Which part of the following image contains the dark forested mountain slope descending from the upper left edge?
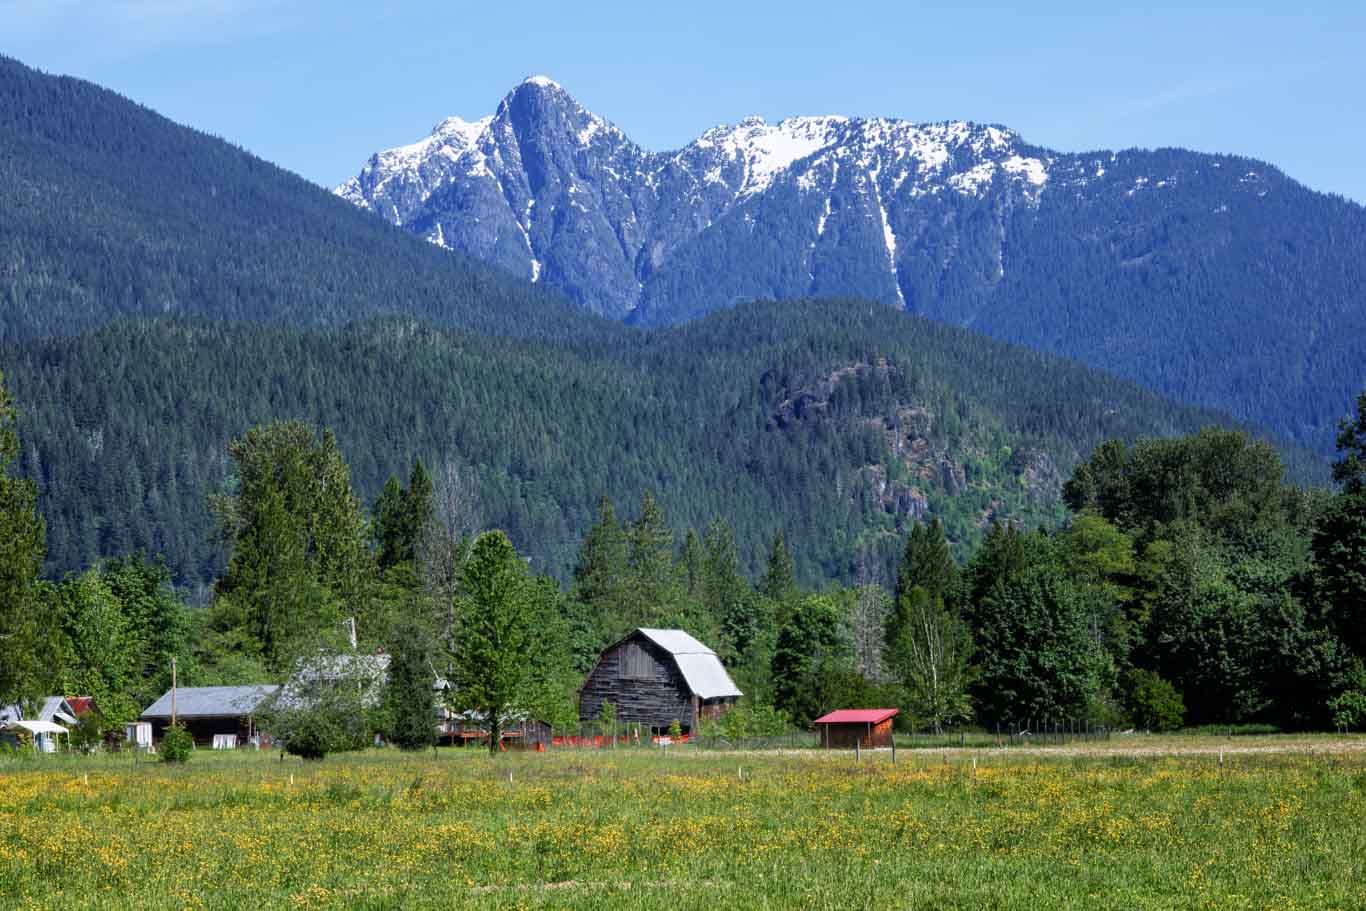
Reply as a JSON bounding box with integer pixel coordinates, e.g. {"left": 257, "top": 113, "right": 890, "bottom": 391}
{"left": 0, "top": 57, "right": 608, "bottom": 340}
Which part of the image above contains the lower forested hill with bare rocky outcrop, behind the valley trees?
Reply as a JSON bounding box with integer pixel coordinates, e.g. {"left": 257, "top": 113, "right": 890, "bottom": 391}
{"left": 0, "top": 300, "right": 1322, "bottom": 595}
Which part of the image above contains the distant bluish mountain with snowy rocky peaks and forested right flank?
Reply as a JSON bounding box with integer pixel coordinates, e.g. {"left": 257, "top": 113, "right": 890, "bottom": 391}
{"left": 337, "top": 76, "right": 1366, "bottom": 453}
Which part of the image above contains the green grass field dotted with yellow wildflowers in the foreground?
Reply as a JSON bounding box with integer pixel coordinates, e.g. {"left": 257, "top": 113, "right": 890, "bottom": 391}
{"left": 0, "top": 738, "right": 1366, "bottom": 911}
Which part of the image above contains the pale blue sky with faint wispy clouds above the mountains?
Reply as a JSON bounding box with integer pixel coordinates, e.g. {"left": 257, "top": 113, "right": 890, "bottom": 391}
{"left": 8, "top": 0, "right": 1366, "bottom": 201}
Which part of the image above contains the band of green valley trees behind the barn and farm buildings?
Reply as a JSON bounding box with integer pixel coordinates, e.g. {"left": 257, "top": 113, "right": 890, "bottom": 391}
{"left": 8, "top": 366, "right": 1366, "bottom": 740}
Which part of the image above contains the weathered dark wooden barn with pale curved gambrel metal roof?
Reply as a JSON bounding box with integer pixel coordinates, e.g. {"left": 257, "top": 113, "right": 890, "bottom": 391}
{"left": 579, "top": 630, "right": 743, "bottom": 733}
